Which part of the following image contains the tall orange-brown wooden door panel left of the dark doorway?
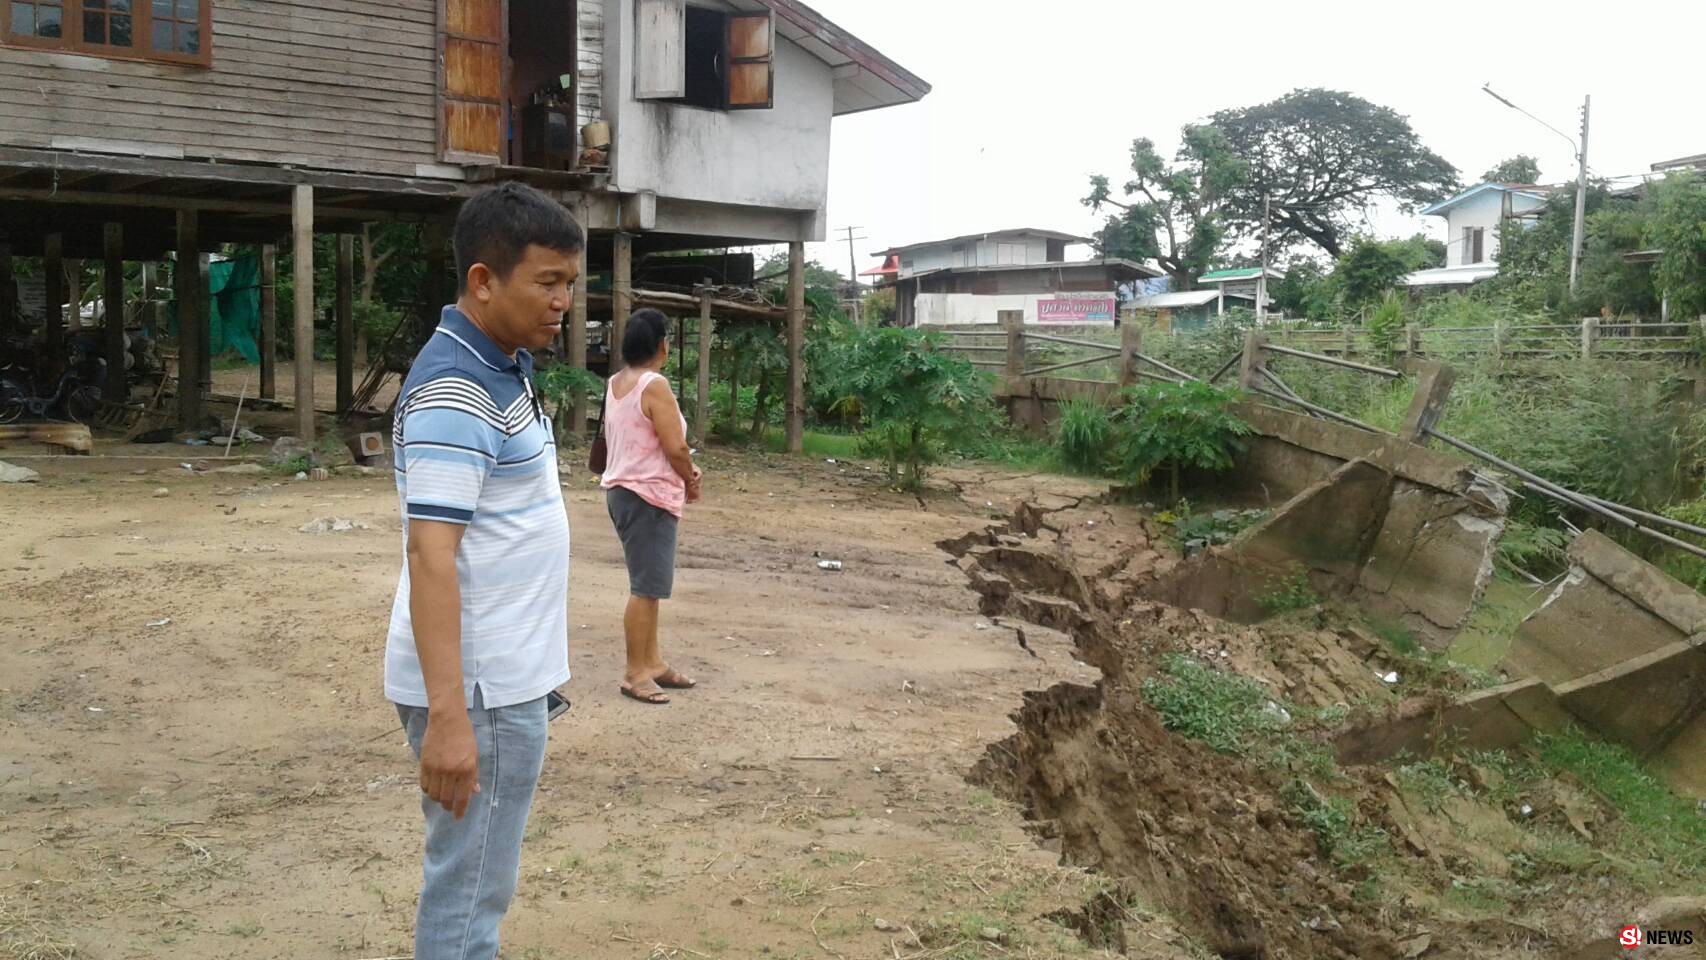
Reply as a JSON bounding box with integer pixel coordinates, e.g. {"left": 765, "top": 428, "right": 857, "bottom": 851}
{"left": 438, "top": 0, "right": 508, "bottom": 164}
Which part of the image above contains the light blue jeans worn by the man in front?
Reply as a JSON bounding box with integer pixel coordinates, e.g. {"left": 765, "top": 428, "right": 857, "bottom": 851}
{"left": 397, "top": 687, "right": 548, "bottom": 960}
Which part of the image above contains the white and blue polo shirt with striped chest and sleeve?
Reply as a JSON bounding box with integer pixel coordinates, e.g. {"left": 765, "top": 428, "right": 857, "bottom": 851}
{"left": 386, "top": 307, "right": 568, "bottom": 708}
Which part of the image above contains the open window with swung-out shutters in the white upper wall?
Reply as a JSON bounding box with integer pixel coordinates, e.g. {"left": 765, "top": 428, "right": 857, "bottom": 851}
{"left": 635, "top": 0, "right": 776, "bottom": 109}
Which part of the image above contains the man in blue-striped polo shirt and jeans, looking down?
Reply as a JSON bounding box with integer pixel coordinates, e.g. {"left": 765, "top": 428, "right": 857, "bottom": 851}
{"left": 386, "top": 184, "right": 585, "bottom": 960}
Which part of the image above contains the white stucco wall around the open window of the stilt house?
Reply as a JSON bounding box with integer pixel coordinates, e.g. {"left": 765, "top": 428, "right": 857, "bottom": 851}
{"left": 602, "top": 0, "right": 834, "bottom": 221}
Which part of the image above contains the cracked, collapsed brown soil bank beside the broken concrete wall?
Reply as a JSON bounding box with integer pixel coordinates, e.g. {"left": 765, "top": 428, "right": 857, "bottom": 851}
{"left": 942, "top": 503, "right": 1617, "bottom": 958}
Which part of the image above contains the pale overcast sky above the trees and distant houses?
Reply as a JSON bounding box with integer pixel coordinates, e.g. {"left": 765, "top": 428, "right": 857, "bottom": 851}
{"left": 807, "top": 0, "right": 1706, "bottom": 271}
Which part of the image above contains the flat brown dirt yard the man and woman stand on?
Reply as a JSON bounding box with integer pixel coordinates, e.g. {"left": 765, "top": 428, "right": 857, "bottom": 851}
{"left": 0, "top": 446, "right": 1146, "bottom": 960}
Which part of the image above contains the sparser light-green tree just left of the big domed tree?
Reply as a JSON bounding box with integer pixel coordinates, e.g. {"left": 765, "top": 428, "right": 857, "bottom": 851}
{"left": 1083, "top": 126, "right": 1245, "bottom": 290}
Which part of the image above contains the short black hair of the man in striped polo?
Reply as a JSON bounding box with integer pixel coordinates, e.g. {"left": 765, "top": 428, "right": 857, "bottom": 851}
{"left": 454, "top": 182, "right": 587, "bottom": 295}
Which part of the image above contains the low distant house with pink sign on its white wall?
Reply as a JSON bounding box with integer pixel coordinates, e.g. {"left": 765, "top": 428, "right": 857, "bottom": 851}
{"left": 877, "top": 228, "right": 1160, "bottom": 327}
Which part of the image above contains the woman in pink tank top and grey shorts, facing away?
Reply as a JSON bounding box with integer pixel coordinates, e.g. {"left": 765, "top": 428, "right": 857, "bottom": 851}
{"left": 601, "top": 310, "right": 699, "bottom": 704}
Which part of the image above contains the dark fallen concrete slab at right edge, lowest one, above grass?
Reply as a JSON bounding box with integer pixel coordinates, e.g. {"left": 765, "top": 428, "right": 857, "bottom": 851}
{"left": 1554, "top": 639, "right": 1706, "bottom": 757}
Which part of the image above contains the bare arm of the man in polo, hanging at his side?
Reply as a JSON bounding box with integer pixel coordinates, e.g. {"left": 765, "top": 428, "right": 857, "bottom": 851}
{"left": 408, "top": 520, "right": 479, "bottom": 820}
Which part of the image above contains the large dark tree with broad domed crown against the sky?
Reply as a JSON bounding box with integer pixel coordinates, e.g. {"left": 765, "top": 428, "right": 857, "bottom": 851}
{"left": 1210, "top": 89, "right": 1459, "bottom": 257}
